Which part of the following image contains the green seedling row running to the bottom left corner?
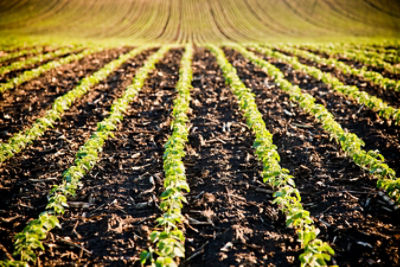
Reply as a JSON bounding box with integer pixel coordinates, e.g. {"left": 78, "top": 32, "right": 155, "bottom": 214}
{"left": 3, "top": 46, "right": 170, "bottom": 265}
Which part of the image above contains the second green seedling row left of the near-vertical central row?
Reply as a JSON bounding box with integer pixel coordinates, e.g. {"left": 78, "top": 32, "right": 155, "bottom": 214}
{"left": 0, "top": 46, "right": 147, "bottom": 163}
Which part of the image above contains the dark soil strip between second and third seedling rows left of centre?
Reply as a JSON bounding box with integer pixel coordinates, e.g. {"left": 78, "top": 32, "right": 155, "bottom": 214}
{"left": 0, "top": 48, "right": 129, "bottom": 141}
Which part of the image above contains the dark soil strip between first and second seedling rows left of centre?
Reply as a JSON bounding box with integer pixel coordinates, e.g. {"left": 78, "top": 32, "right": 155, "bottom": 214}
{"left": 0, "top": 47, "right": 150, "bottom": 262}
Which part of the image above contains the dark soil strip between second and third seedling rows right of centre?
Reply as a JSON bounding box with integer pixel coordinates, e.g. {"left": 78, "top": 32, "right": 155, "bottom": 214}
{"left": 270, "top": 49, "right": 400, "bottom": 177}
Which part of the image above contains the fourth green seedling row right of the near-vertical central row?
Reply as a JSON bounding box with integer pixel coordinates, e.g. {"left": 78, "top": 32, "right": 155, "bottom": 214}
{"left": 279, "top": 46, "right": 400, "bottom": 92}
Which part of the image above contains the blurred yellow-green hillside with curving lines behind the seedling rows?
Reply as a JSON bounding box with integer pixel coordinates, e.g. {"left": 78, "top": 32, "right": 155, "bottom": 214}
{"left": 0, "top": 0, "right": 400, "bottom": 44}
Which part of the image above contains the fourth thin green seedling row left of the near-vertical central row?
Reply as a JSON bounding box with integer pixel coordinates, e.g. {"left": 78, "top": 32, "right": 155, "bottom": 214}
{"left": 0, "top": 47, "right": 76, "bottom": 75}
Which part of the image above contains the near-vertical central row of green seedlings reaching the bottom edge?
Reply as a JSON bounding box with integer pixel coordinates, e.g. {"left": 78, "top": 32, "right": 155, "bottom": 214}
{"left": 140, "top": 44, "right": 193, "bottom": 266}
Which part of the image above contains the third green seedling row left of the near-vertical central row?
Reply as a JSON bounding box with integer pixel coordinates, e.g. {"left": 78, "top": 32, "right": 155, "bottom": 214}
{"left": 0, "top": 48, "right": 100, "bottom": 93}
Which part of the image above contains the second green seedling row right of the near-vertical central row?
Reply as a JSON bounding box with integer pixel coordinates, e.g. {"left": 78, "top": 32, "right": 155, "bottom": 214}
{"left": 235, "top": 46, "right": 400, "bottom": 204}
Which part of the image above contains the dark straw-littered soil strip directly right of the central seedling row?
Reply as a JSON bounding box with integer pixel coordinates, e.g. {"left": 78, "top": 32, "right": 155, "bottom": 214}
{"left": 184, "top": 50, "right": 300, "bottom": 266}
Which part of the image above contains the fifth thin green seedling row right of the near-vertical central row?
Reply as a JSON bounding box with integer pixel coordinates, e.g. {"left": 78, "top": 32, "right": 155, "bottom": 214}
{"left": 305, "top": 45, "right": 400, "bottom": 74}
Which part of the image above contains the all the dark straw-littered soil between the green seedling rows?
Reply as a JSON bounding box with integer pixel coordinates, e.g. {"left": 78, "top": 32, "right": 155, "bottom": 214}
{"left": 0, "top": 46, "right": 400, "bottom": 266}
